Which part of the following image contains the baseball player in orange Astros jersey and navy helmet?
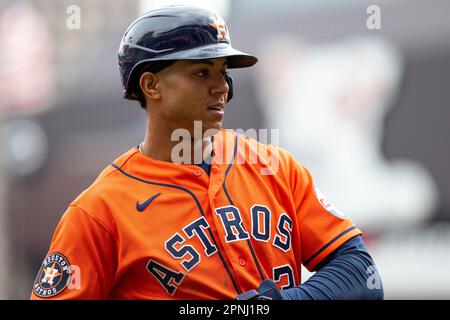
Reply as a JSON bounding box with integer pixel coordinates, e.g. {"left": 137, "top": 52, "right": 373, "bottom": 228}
{"left": 31, "top": 6, "right": 383, "bottom": 299}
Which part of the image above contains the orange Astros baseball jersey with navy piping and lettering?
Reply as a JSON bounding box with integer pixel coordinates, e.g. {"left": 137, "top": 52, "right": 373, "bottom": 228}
{"left": 31, "top": 130, "right": 361, "bottom": 299}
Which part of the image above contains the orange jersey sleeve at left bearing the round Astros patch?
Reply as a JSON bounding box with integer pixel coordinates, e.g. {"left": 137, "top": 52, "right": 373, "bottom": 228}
{"left": 31, "top": 205, "right": 117, "bottom": 299}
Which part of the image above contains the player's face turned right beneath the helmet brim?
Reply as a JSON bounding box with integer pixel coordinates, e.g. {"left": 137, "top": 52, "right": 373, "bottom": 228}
{"left": 158, "top": 58, "right": 229, "bottom": 135}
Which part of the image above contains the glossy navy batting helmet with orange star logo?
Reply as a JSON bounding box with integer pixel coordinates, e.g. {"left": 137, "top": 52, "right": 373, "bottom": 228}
{"left": 119, "top": 5, "right": 258, "bottom": 104}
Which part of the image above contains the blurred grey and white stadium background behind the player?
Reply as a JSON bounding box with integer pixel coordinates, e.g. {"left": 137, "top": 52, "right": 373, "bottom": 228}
{"left": 0, "top": 0, "right": 450, "bottom": 299}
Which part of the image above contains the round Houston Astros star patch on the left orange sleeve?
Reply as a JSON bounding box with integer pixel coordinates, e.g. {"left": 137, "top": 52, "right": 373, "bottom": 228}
{"left": 33, "top": 252, "right": 70, "bottom": 298}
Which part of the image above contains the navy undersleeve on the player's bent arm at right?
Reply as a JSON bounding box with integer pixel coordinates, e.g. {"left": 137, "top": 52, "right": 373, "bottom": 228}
{"left": 281, "top": 236, "right": 384, "bottom": 300}
